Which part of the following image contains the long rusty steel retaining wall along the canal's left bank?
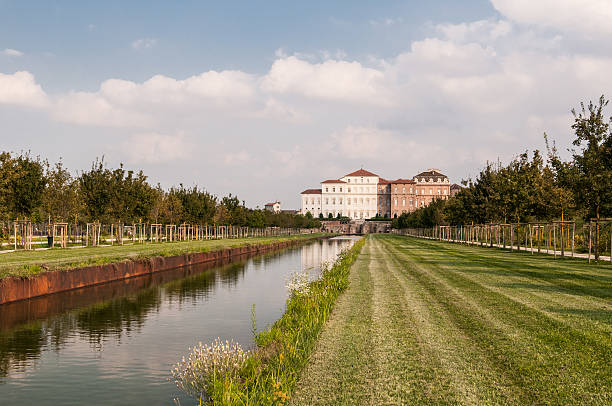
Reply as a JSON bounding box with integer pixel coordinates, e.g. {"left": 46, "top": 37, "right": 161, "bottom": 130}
{"left": 0, "top": 237, "right": 324, "bottom": 305}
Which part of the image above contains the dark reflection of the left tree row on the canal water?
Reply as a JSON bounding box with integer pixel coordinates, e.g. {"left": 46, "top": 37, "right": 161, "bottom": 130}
{"left": 0, "top": 239, "right": 326, "bottom": 378}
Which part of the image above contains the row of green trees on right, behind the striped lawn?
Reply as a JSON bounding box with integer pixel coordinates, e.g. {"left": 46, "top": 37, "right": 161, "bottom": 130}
{"left": 393, "top": 96, "right": 612, "bottom": 228}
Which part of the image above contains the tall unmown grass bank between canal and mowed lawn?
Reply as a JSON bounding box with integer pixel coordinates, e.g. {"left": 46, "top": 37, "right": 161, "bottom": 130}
{"left": 172, "top": 239, "right": 364, "bottom": 405}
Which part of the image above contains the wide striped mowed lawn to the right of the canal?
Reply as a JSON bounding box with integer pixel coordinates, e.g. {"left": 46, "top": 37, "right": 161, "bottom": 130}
{"left": 292, "top": 235, "right": 612, "bottom": 405}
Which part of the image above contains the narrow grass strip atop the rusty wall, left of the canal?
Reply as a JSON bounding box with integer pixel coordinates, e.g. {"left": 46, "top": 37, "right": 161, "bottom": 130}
{"left": 0, "top": 234, "right": 323, "bottom": 279}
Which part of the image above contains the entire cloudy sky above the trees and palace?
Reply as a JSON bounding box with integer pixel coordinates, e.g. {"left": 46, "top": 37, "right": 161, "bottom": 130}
{"left": 0, "top": 0, "right": 612, "bottom": 209}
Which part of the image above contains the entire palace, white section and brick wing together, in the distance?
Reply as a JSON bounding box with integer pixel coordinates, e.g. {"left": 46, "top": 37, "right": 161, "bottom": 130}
{"left": 300, "top": 169, "right": 450, "bottom": 220}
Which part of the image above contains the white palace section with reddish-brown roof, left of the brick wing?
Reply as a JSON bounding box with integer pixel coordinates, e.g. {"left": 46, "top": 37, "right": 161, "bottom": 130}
{"left": 301, "top": 169, "right": 380, "bottom": 219}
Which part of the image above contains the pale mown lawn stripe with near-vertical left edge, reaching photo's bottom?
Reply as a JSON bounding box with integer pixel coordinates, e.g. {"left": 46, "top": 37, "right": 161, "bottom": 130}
{"left": 370, "top": 236, "right": 455, "bottom": 405}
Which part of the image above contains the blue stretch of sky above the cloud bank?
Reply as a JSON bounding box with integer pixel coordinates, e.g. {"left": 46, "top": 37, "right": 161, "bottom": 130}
{"left": 0, "top": 0, "right": 496, "bottom": 91}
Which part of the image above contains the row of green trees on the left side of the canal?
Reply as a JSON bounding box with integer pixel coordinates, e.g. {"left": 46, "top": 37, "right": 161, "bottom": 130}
{"left": 0, "top": 152, "right": 320, "bottom": 228}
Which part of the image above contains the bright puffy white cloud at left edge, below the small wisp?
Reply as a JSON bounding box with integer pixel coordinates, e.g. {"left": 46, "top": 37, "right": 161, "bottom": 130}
{"left": 0, "top": 72, "right": 48, "bottom": 108}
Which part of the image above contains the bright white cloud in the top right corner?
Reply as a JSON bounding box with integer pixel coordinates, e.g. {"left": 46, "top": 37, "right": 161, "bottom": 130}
{"left": 491, "top": 0, "right": 612, "bottom": 36}
